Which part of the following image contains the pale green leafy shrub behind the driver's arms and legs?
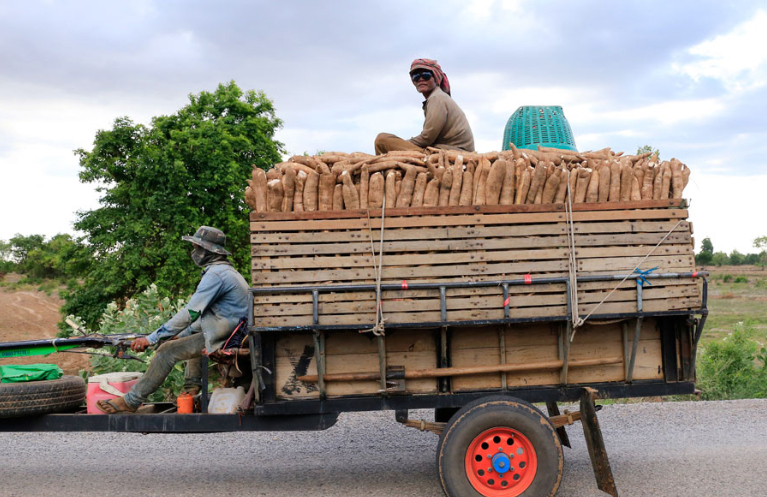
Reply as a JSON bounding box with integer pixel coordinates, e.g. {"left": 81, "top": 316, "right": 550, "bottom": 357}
{"left": 69, "top": 285, "right": 190, "bottom": 402}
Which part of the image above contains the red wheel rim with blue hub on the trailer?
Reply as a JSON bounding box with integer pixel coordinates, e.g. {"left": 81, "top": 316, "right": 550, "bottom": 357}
{"left": 466, "top": 427, "right": 538, "bottom": 497}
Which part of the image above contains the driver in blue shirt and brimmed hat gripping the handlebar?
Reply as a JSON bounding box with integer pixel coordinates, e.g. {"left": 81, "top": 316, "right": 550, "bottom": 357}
{"left": 97, "top": 226, "right": 251, "bottom": 414}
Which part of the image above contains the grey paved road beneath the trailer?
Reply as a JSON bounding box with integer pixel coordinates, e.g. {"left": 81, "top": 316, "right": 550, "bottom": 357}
{"left": 0, "top": 400, "right": 767, "bottom": 497}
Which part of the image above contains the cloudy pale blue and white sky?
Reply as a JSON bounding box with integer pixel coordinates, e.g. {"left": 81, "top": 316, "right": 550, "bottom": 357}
{"left": 0, "top": 0, "right": 767, "bottom": 253}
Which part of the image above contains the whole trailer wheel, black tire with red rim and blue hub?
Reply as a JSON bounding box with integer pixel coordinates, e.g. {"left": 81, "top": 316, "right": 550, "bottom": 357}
{"left": 437, "top": 396, "right": 564, "bottom": 497}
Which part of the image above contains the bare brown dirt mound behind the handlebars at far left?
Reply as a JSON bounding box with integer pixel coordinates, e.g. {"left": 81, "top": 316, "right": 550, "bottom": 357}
{"left": 0, "top": 284, "right": 89, "bottom": 375}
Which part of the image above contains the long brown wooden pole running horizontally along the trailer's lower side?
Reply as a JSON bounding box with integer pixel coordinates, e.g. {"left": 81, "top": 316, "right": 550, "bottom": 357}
{"left": 296, "top": 357, "right": 623, "bottom": 382}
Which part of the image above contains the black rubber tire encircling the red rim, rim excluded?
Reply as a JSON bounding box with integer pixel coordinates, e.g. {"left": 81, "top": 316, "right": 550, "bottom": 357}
{"left": 437, "top": 396, "right": 564, "bottom": 497}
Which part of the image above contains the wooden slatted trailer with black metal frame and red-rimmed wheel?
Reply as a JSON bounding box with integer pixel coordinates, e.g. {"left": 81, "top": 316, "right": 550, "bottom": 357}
{"left": 0, "top": 200, "right": 707, "bottom": 497}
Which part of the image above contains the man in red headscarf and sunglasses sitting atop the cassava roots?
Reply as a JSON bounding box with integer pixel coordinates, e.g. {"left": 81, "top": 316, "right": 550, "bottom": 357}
{"left": 375, "top": 59, "right": 474, "bottom": 154}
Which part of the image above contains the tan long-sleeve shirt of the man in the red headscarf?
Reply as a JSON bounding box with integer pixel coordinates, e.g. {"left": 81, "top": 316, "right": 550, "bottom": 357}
{"left": 408, "top": 87, "right": 474, "bottom": 152}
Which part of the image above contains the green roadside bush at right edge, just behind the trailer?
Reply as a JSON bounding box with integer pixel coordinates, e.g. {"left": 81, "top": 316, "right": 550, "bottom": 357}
{"left": 698, "top": 322, "right": 767, "bottom": 400}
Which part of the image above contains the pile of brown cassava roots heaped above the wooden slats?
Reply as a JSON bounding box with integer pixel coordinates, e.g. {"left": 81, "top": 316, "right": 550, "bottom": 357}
{"left": 245, "top": 143, "right": 690, "bottom": 212}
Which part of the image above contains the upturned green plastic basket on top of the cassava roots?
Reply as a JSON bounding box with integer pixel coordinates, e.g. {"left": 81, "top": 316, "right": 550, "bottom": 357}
{"left": 502, "top": 105, "right": 578, "bottom": 151}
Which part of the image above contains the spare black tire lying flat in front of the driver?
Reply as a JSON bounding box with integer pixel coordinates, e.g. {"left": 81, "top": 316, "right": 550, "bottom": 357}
{"left": 0, "top": 376, "right": 86, "bottom": 418}
